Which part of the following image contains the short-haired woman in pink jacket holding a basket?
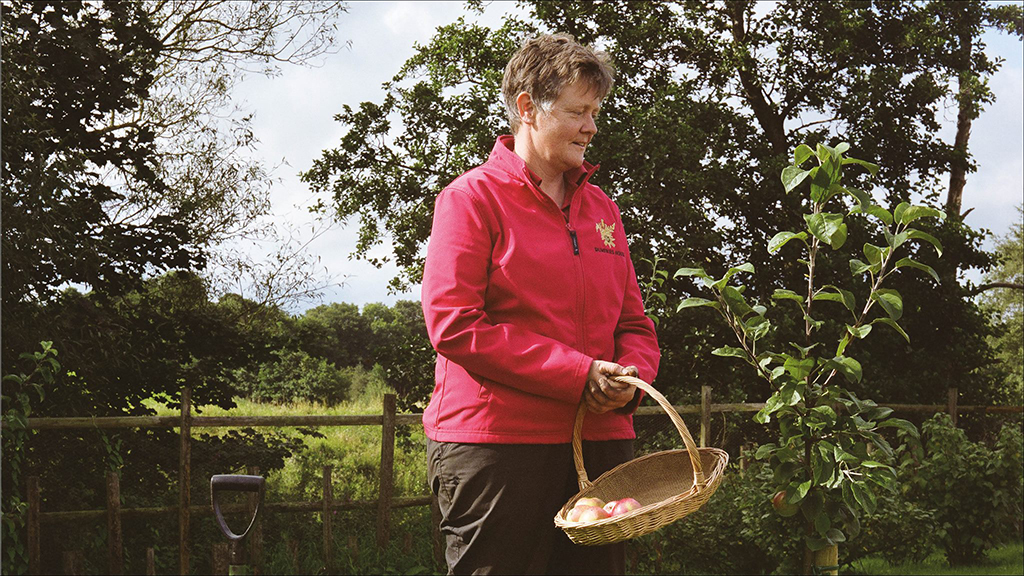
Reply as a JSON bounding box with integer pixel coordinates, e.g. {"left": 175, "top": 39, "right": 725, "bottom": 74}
{"left": 422, "top": 35, "right": 659, "bottom": 574}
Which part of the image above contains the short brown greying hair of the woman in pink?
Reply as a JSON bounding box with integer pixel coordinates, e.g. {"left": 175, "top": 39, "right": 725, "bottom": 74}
{"left": 502, "top": 34, "right": 613, "bottom": 134}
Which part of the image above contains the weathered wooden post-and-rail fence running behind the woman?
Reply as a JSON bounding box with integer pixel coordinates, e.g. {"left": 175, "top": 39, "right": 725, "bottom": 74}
{"left": 5, "top": 386, "right": 1024, "bottom": 574}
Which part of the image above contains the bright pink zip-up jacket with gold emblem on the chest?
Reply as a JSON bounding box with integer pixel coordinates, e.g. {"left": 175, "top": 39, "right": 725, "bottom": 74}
{"left": 422, "top": 136, "right": 660, "bottom": 444}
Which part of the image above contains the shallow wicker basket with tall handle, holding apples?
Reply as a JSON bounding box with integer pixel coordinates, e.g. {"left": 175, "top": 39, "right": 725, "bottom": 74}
{"left": 555, "top": 376, "right": 729, "bottom": 546}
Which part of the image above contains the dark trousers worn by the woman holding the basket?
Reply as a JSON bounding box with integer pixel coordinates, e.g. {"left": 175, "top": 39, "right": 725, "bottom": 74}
{"left": 427, "top": 440, "right": 633, "bottom": 574}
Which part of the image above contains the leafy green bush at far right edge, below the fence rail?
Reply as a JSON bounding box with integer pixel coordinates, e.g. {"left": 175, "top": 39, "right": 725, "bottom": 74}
{"left": 901, "top": 414, "right": 1024, "bottom": 566}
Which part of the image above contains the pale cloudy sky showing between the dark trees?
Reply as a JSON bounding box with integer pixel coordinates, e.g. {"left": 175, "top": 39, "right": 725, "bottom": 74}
{"left": 234, "top": 2, "right": 1024, "bottom": 314}
